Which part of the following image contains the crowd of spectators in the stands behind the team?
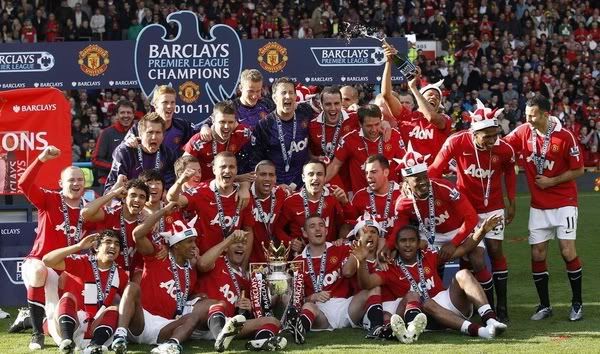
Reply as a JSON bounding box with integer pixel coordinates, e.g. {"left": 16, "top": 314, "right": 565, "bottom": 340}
{"left": 0, "top": 0, "right": 600, "bottom": 167}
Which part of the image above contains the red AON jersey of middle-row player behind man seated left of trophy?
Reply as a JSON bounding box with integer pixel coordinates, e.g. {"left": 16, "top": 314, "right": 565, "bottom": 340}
{"left": 185, "top": 180, "right": 254, "bottom": 254}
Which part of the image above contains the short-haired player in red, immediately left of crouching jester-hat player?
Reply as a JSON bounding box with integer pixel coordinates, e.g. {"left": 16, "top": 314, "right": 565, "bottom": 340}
{"left": 351, "top": 154, "right": 401, "bottom": 241}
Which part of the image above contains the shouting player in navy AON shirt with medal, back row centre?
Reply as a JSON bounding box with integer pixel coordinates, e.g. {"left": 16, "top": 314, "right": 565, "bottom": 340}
{"left": 251, "top": 77, "right": 313, "bottom": 190}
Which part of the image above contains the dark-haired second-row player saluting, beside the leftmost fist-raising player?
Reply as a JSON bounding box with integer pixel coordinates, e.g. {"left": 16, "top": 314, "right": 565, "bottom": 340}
{"left": 81, "top": 179, "right": 150, "bottom": 276}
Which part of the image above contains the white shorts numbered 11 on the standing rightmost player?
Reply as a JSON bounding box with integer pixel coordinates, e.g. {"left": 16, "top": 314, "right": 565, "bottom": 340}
{"left": 529, "top": 206, "right": 578, "bottom": 245}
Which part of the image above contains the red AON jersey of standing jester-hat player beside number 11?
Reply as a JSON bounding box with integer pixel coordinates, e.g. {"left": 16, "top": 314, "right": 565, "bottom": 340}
{"left": 429, "top": 131, "right": 517, "bottom": 213}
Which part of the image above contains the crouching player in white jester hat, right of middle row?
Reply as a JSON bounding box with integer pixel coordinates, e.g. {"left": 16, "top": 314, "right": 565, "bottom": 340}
{"left": 394, "top": 151, "right": 484, "bottom": 271}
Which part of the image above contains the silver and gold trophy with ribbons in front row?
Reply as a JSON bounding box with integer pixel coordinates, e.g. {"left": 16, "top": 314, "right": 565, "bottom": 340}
{"left": 250, "top": 241, "right": 304, "bottom": 322}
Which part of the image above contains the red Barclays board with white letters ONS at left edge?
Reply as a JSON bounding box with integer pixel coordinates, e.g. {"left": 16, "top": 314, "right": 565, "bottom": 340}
{"left": 0, "top": 88, "right": 71, "bottom": 194}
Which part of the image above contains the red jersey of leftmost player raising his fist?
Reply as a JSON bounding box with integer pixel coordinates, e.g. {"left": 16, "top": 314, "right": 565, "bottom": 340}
{"left": 19, "top": 159, "right": 96, "bottom": 260}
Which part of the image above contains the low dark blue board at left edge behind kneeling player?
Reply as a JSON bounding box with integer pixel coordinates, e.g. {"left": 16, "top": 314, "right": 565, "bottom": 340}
{"left": 0, "top": 222, "right": 37, "bottom": 306}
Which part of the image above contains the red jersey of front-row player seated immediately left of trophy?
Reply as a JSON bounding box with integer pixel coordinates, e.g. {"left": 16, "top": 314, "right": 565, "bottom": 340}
{"left": 196, "top": 256, "right": 250, "bottom": 317}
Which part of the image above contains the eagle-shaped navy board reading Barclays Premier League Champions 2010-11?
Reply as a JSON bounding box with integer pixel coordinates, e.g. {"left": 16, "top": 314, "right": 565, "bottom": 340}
{"left": 135, "top": 11, "right": 243, "bottom": 122}
